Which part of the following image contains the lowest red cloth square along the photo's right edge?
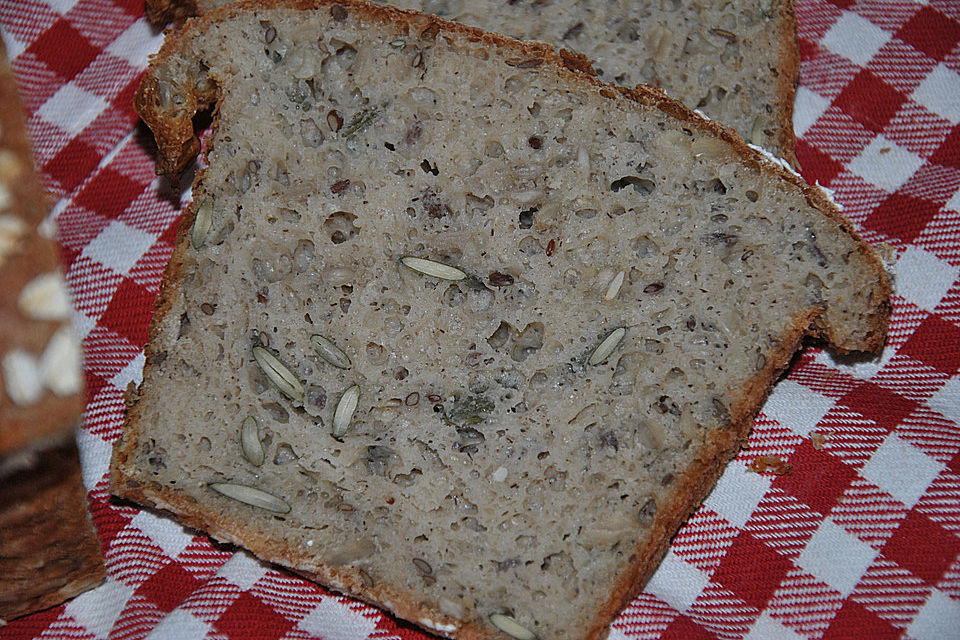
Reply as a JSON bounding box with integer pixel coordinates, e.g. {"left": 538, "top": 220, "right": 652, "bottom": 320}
{"left": 880, "top": 510, "right": 960, "bottom": 585}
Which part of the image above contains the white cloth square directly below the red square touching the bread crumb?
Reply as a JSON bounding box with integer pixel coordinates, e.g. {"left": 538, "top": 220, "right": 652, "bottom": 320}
{"left": 797, "top": 518, "right": 879, "bottom": 598}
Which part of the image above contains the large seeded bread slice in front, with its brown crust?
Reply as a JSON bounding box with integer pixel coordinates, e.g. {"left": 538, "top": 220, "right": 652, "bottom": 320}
{"left": 111, "top": 1, "right": 890, "bottom": 640}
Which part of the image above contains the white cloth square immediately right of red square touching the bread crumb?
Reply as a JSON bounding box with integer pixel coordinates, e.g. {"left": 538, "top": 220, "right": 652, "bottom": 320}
{"left": 860, "top": 433, "right": 945, "bottom": 508}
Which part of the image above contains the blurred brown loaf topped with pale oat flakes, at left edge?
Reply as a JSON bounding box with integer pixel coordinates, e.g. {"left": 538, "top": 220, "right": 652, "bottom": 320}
{"left": 0, "top": 44, "right": 104, "bottom": 619}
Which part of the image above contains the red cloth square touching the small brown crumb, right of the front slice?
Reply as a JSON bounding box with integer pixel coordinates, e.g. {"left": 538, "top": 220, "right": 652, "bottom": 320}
{"left": 772, "top": 440, "right": 857, "bottom": 515}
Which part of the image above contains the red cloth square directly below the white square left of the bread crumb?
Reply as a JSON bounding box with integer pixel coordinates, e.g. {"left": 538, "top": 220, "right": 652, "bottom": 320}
{"left": 711, "top": 531, "right": 793, "bottom": 610}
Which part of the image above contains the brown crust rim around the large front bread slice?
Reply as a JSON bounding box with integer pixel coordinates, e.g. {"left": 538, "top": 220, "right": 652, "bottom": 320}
{"left": 118, "top": 0, "right": 892, "bottom": 640}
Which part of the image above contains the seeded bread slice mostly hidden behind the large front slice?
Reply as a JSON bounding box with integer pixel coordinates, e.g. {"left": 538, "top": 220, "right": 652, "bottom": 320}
{"left": 146, "top": 0, "right": 799, "bottom": 166}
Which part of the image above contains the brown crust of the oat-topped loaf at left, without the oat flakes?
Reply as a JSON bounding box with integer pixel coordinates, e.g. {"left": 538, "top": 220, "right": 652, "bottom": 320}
{"left": 0, "top": 43, "right": 106, "bottom": 620}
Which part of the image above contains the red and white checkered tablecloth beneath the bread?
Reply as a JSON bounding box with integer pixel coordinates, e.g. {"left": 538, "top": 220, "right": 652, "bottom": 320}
{"left": 0, "top": 0, "right": 960, "bottom": 640}
